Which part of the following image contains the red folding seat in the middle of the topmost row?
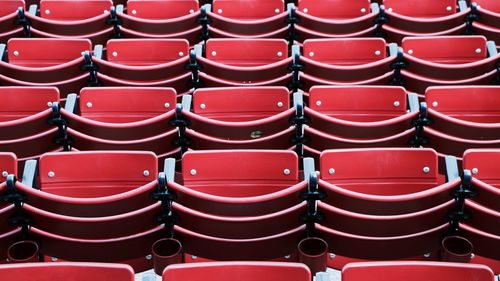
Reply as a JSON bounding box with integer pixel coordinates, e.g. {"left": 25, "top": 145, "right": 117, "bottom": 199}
{"left": 208, "top": 0, "right": 288, "bottom": 38}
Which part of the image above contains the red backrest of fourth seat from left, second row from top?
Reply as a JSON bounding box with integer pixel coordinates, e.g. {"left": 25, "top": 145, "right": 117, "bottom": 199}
{"left": 304, "top": 38, "right": 387, "bottom": 65}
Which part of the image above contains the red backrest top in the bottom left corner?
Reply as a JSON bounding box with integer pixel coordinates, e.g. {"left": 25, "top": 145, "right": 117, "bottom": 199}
{"left": 0, "top": 262, "right": 134, "bottom": 281}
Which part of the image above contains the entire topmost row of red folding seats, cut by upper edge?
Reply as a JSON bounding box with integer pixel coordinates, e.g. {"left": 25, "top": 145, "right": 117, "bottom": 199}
{"left": 0, "top": 0, "right": 500, "bottom": 45}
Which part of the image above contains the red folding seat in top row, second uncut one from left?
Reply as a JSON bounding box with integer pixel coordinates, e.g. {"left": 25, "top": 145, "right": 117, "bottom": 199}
{"left": 115, "top": 0, "right": 201, "bottom": 45}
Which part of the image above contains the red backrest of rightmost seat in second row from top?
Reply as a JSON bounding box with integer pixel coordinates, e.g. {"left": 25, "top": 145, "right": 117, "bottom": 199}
{"left": 402, "top": 36, "right": 488, "bottom": 64}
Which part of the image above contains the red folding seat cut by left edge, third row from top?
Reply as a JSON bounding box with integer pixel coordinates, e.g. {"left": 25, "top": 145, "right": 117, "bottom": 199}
{"left": 0, "top": 87, "right": 60, "bottom": 160}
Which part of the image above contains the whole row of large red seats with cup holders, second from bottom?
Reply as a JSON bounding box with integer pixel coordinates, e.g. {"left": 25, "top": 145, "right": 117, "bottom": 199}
{"left": 0, "top": 148, "right": 500, "bottom": 273}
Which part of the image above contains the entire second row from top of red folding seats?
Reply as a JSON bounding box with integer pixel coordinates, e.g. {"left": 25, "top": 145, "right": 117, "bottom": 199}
{"left": 0, "top": 36, "right": 500, "bottom": 97}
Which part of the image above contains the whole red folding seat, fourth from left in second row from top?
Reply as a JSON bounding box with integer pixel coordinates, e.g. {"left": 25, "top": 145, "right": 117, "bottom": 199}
{"left": 300, "top": 38, "right": 397, "bottom": 87}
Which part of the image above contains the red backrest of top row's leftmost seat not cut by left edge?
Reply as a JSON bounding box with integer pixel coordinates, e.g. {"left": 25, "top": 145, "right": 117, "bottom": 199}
{"left": 40, "top": 0, "right": 113, "bottom": 21}
